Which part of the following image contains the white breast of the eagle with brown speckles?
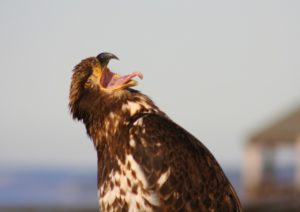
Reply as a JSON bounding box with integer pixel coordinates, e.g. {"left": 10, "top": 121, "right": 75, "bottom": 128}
{"left": 99, "top": 154, "right": 159, "bottom": 211}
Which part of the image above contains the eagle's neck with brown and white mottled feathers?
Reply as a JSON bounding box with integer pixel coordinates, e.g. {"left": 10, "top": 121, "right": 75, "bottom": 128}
{"left": 87, "top": 93, "right": 165, "bottom": 152}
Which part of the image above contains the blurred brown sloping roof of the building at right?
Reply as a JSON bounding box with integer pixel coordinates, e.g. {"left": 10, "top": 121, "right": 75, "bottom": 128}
{"left": 250, "top": 107, "right": 300, "bottom": 144}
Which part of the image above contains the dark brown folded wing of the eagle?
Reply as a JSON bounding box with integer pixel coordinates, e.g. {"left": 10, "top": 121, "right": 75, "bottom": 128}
{"left": 129, "top": 114, "right": 242, "bottom": 211}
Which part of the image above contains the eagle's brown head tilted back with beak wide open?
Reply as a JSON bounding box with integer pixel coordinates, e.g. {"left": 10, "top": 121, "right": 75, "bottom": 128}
{"left": 69, "top": 52, "right": 143, "bottom": 119}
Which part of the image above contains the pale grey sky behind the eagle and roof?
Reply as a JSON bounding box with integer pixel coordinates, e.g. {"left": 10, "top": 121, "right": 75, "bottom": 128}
{"left": 0, "top": 0, "right": 300, "bottom": 169}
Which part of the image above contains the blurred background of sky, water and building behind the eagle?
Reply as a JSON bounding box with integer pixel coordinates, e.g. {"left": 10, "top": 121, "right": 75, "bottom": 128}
{"left": 0, "top": 0, "right": 300, "bottom": 211}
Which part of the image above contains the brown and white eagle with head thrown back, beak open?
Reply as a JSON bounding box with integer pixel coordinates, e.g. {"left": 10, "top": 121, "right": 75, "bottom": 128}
{"left": 69, "top": 52, "right": 242, "bottom": 212}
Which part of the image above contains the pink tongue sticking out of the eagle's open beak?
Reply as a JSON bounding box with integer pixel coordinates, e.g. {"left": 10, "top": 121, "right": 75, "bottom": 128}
{"left": 105, "top": 72, "right": 143, "bottom": 88}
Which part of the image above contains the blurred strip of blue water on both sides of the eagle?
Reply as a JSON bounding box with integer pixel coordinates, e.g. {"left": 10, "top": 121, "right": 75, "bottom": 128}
{"left": 0, "top": 166, "right": 240, "bottom": 207}
